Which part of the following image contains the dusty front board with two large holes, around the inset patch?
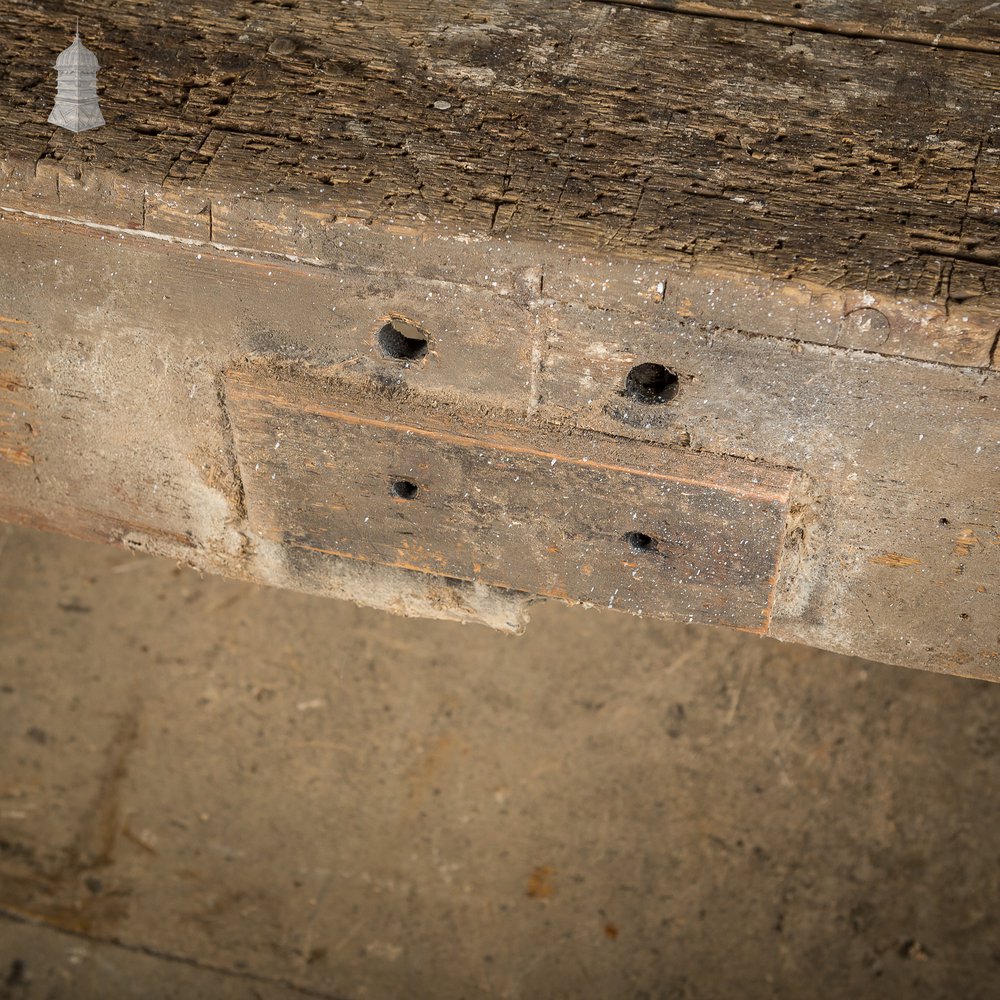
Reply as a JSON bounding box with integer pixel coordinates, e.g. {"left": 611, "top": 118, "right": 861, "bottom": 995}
{"left": 0, "top": 204, "right": 1000, "bottom": 677}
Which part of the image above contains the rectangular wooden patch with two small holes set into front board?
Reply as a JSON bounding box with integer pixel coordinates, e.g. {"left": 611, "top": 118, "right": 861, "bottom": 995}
{"left": 226, "top": 371, "right": 794, "bottom": 632}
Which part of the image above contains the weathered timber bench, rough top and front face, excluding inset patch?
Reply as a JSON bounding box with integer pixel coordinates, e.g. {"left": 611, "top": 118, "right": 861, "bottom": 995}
{"left": 0, "top": 0, "right": 1000, "bottom": 677}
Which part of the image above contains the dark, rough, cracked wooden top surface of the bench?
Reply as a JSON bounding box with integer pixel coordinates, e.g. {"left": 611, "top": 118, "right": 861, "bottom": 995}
{"left": 0, "top": 0, "right": 1000, "bottom": 335}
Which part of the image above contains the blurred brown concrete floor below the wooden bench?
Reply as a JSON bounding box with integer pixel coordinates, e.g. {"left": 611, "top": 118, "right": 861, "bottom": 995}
{"left": 0, "top": 526, "right": 1000, "bottom": 1000}
